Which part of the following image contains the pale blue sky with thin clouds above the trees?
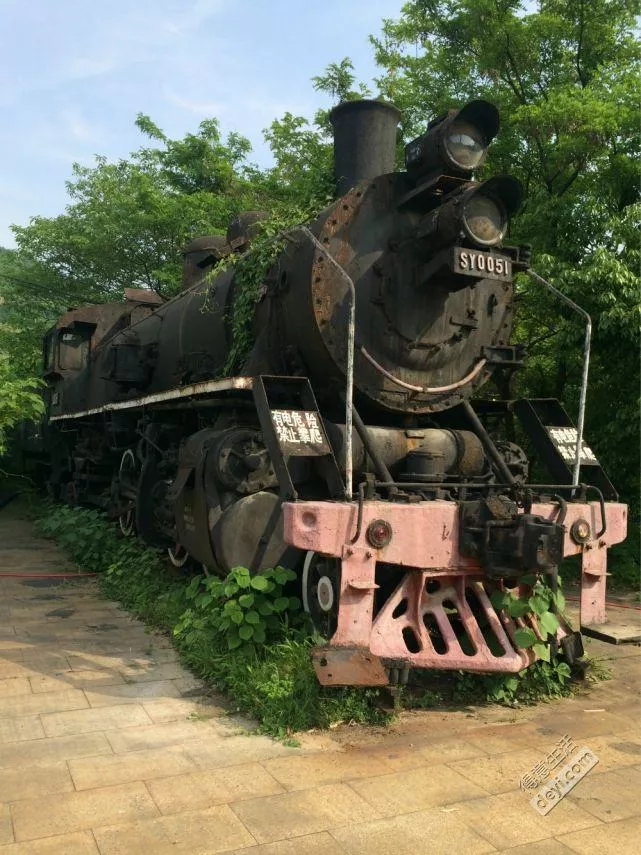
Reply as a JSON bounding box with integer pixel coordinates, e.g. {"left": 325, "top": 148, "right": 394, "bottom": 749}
{"left": 0, "top": 0, "right": 402, "bottom": 246}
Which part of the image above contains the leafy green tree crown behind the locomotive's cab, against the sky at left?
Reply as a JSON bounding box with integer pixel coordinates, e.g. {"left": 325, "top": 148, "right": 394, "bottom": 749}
{"left": 14, "top": 115, "right": 253, "bottom": 300}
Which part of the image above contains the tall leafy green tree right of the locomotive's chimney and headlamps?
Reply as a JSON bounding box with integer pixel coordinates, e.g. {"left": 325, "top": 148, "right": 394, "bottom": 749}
{"left": 372, "top": 0, "right": 641, "bottom": 568}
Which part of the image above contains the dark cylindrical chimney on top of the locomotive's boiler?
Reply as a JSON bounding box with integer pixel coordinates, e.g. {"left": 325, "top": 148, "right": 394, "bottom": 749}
{"left": 329, "top": 99, "right": 401, "bottom": 196}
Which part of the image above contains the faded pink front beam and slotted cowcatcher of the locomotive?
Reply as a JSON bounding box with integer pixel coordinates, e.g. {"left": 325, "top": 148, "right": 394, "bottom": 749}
{"left": 283, "top": 501, "right": 627, "bottom": 672}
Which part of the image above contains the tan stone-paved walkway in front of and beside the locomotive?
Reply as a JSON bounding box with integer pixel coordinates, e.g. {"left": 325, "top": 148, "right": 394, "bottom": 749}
{"left": 0, "top": 508, "right": 641, "bottom": 855}
